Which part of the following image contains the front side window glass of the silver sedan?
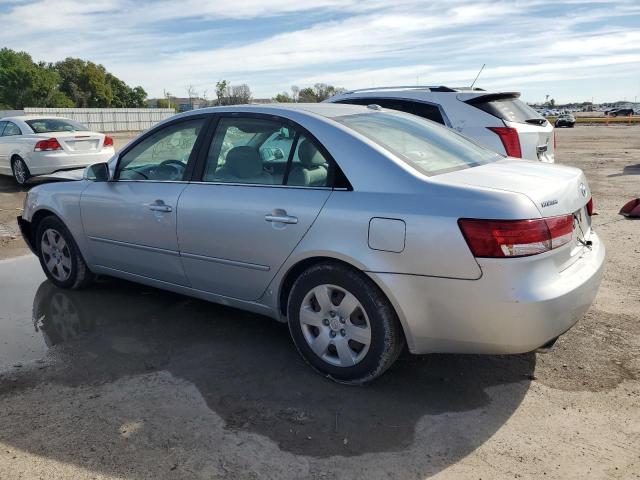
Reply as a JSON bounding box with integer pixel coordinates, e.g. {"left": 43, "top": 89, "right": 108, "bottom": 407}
{"left": 116, "top": 119, "right": 205, "bottom": 181}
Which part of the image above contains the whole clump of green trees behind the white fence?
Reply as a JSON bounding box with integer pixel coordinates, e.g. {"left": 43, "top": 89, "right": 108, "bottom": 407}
{"left": 0, "top": 48, "right": 147, "bottom": 109}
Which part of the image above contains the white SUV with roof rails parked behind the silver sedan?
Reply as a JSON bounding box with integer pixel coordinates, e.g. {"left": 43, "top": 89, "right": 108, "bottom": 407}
{"left": 326, "top": 86, "right": 555, "bottom": 163}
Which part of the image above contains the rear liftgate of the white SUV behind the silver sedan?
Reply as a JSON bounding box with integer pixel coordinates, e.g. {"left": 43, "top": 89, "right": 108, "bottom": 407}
{"left": 466, "top": 93, "right": 555, "bottom": 163}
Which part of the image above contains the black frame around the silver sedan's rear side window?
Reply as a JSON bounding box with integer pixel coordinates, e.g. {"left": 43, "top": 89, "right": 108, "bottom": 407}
{"left": 190, "top": 112, "right": 353, "bottom": 190}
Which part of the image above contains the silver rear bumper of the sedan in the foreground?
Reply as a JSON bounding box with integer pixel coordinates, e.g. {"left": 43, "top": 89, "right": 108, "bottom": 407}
{"left": 369, "top": 234, "right": 605, "bottom": 354}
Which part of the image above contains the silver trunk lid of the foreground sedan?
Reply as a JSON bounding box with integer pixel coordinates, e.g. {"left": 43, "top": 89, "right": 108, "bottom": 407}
{"left": 432, "top": 158, "right": 591, "bottom": 270}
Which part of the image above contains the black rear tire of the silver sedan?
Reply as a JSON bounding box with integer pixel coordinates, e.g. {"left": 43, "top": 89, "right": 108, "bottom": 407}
{"left": 287, "top": 263, "right": 405, "bottom": 384}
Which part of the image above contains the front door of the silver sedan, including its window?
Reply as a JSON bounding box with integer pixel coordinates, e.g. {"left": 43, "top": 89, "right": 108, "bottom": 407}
{"left": 80, "top": 118, "right": 205, "bottom": 285}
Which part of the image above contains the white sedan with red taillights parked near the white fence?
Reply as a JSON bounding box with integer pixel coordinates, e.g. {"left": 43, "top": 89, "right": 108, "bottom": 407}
{"left": 0, "top": 116, "right": 115, "bottom": 185}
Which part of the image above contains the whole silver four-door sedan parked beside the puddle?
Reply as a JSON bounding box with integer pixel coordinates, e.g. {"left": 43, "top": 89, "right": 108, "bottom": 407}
{"left": 18, "top": 104, "right": 605, "bottom": 383}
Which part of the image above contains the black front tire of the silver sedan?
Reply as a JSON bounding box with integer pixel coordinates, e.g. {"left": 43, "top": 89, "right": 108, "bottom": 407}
{"left": 34, "top": 215, "right": 95, "bottom": 290}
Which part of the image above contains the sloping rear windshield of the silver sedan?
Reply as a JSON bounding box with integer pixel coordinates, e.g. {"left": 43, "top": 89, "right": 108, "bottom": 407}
{"left": 334, "top": 112, "right": 502, "bottom": 175}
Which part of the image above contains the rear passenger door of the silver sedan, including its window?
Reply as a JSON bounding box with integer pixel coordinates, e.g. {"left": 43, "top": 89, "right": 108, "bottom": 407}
{"left": 178, "top": 115, "right": 332, "bottom": 300}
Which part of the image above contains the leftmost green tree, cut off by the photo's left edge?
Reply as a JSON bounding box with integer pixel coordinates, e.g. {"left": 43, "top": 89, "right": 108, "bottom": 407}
{"left": 0, "top": 48, "right": 73, "bottom": 109}
